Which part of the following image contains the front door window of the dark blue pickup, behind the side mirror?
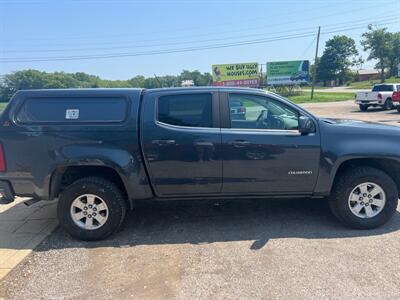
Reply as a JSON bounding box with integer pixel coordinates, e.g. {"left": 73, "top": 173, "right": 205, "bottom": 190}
{"left": 229, "top": 94, "right": 299, "bottom": 130}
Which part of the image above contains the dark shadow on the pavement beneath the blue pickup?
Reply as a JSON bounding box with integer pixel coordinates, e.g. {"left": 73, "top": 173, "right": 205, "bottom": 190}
{"left": 36, "top": 199, "right": 400, "bottom": 251}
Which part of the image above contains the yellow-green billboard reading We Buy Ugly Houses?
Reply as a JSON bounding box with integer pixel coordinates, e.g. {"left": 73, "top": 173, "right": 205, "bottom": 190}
{"left": 212, "top": 63, "right": 260, "bottom": 87}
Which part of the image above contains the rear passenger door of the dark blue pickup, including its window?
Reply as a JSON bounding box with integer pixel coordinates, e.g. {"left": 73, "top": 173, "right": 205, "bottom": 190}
{"left": 141, "top": 90, "right": 222, "bottom": 197}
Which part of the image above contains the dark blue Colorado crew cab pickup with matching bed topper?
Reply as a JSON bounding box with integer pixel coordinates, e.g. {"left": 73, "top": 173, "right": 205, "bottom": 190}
{"left": 0, "top": 87, "right": 400, "bottom": 240}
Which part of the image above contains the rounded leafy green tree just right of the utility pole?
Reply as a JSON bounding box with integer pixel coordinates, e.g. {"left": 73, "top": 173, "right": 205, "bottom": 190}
{"left": 317, "top": 35, "right": 361, "bottom": 85}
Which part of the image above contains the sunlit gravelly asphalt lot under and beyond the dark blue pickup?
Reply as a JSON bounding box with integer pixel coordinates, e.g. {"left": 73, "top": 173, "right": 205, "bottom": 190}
{"left": 0, "top": 101, "right": 400, "bottom": 299}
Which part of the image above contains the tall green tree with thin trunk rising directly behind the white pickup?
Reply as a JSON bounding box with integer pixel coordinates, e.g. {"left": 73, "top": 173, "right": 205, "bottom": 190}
{"left": 361, "top": 25, "right": 392, "bottom": 82}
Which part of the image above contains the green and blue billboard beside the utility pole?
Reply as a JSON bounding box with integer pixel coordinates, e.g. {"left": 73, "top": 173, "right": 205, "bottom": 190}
{"left": 267, "top": 60, "right": 310, "bottom": 85}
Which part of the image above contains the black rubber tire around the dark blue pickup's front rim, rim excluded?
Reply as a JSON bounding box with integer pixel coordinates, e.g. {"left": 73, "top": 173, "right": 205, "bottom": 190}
{"left": 329, "top": 167, "right": 398, "bottom": 229}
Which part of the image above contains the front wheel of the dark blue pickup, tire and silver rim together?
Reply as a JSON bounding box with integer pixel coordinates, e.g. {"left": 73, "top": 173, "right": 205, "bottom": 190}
{"left": 329, "top": 167, "right": 398, "bottom": 229}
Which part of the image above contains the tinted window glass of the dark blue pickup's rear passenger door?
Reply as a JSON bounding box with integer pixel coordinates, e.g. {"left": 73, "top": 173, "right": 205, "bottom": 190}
{"left": 157, "top": 93, "right": 212, "bottom": 127}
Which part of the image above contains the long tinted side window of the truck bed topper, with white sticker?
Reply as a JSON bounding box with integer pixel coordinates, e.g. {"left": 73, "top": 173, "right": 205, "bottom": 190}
{"left": 17, "top": 97, "right": 127, "bottom": 123}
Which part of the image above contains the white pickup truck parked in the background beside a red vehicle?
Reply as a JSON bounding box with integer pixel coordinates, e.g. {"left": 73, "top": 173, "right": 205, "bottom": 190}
{"left": 356, "top": 83, "right": 400, "bottom": 112}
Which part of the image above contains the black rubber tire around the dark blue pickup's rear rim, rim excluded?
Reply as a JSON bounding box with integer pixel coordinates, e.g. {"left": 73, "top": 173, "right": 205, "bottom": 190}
{"left": 57, "top": 177, "right": 126, "bottom": 241}
